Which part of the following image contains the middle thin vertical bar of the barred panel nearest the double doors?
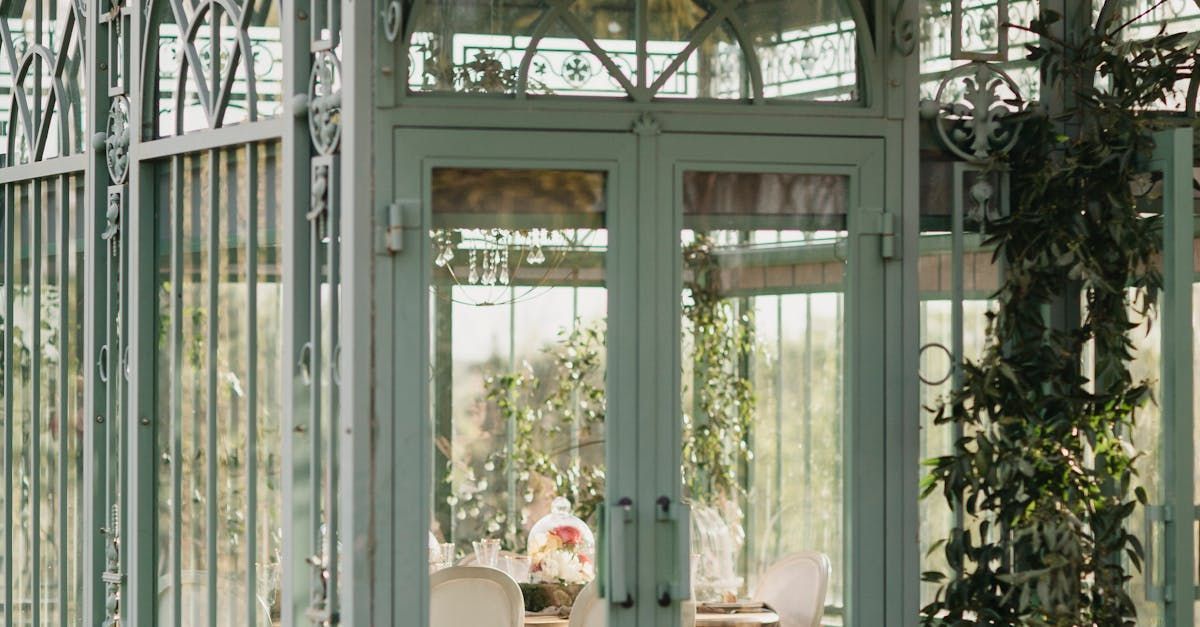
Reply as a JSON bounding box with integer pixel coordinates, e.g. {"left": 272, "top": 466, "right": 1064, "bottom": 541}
{"left": 204, "top": 145, "right": 221, "bottom": 627}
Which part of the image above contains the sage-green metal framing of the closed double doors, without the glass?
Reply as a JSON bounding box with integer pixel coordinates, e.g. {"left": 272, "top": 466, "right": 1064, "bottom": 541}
{"left": 376, "top": 118, "right": 905, "bottom": 626}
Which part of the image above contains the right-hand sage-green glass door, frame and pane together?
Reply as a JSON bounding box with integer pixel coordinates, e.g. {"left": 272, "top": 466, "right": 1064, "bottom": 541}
{"left": 642, "top": 135, "right": 896, "bottom": 625}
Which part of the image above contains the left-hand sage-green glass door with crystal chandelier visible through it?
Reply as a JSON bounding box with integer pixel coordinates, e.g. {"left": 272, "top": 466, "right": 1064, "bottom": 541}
{"left": 396, "top": 130, "right": 637, "bottom": 626}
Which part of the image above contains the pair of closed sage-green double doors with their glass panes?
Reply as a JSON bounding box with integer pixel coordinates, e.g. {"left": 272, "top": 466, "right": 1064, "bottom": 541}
{"left": 391, "top": 130, "right": 890, "bottom": 627}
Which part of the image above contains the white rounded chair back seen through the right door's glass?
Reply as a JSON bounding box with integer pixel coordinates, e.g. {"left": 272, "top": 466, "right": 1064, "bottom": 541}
{"left": 755, "top": 551, "right": 833, "bottom": 627}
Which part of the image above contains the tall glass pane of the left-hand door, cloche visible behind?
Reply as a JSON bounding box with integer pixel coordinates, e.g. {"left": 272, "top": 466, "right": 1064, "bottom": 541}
{"left": 430, "top": 168, "right": 608, "bottom": 625}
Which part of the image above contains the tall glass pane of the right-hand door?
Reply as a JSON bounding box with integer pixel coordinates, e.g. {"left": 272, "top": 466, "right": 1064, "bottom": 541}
{"left": 680, "top": 172, "right": 848, "bottom": 617}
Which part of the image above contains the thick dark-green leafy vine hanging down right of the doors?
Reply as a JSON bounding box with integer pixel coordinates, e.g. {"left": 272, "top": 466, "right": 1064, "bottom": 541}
{"left": 923, "top": 6, "right": 1196, "bottom": 626}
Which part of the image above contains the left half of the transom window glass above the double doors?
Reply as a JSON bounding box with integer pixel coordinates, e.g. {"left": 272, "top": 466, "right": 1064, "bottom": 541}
{"left": 408, "top": 0, "right": 637, "bottom": 97}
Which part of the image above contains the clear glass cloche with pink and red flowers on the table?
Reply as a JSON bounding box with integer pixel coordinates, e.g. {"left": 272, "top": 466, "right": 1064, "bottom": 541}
{"left": 528, "top": 496, "right": 596, "bottom": 585}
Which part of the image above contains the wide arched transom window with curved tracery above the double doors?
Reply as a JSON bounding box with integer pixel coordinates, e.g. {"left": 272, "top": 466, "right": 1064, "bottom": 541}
{"left": 408, "top": 0, "right": 869, "bottom": 102}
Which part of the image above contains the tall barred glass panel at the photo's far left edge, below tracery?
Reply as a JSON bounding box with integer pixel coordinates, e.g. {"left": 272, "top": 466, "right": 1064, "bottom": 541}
{"left": 0, "top": 174, "right": 83, "bottom": 625}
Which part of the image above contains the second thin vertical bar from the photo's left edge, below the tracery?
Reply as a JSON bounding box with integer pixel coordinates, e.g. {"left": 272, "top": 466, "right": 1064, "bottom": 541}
{"left": 29, "top": 176, "right": 46, "bottom": 625}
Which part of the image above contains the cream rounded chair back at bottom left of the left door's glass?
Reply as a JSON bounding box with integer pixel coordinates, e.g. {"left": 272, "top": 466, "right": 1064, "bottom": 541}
{"left": 430, "top": 566, "right": 524, "bottom": 627}
